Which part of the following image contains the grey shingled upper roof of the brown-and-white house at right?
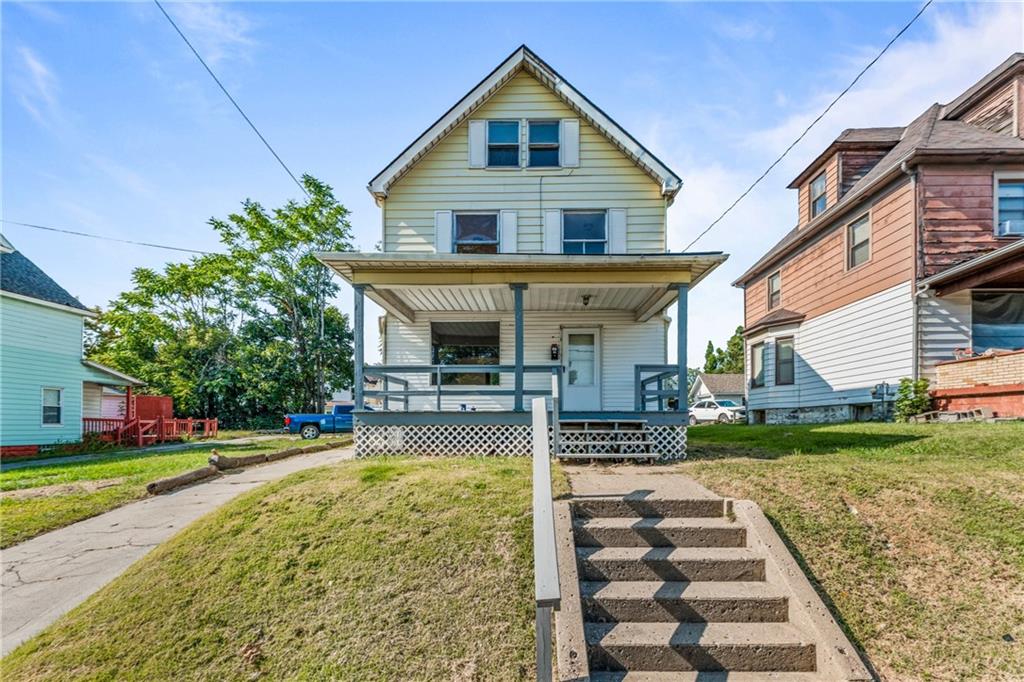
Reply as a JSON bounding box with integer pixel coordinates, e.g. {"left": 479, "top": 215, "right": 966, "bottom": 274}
{"left": 732, "top": 53, "right": 1024, "bottom": 287}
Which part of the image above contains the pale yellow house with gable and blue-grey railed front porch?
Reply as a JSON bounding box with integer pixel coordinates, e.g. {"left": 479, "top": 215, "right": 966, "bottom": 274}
{"left": 321, "top": 46, "right": 725, "bottom": 457}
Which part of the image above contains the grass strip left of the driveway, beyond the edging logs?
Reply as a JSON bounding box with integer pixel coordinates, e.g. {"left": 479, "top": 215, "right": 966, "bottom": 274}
{"left": 0, "top": 438, "right": 348, "bottom": 547}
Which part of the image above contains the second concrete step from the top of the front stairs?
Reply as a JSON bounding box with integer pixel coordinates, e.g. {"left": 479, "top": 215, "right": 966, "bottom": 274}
{"left": 572, "top": 516, "right": 746, "bottom": 547}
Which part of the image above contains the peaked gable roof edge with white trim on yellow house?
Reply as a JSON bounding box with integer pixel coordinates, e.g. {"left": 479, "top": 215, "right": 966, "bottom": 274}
{"left": 367, "top": 45, "right": 683, "bottom": 201}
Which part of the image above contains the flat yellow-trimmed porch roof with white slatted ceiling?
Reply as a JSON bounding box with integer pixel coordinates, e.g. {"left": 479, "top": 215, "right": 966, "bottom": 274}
{"left": 318, "top": 252, "right": 727, "bottom": 323}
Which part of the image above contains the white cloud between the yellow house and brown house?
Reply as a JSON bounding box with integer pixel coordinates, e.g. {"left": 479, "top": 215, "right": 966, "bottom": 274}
{"left": 655, "top": 4, "right": 1024, "bottom": 367}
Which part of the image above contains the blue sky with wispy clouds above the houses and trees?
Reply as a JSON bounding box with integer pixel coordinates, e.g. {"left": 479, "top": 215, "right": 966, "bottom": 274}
{"left": 0, "top": 2, "right": 1024, "bottom": 365}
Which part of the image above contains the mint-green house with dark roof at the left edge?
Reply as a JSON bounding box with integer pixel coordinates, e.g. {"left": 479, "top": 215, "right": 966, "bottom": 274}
{"left": 0, "top": 236, "right": 142, "bottom": 457}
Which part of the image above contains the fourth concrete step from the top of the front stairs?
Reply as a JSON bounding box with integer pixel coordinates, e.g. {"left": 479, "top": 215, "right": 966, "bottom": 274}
{"left": 580, "top": 581, "right": 790, "bottom": 623}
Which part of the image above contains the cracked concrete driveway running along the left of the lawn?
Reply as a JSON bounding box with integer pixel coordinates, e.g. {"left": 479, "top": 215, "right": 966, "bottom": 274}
{"left": 0, "top": 445, "right": 354, "bottom": 655}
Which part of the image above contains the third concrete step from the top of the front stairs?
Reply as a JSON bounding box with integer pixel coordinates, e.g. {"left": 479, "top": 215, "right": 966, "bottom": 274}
{"left": 577, "top": 547, "right": 765, "bottom": 582}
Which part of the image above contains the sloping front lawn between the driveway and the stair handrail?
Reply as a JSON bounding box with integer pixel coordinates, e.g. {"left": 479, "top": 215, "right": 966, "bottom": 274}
{"left": 3, "top": 458, "right": 567, "bottom": 682}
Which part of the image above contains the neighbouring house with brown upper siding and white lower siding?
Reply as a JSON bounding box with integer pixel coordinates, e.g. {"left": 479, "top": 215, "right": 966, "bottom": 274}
{"left": 734, "top": 53, "right": 1024, "bottom": 423}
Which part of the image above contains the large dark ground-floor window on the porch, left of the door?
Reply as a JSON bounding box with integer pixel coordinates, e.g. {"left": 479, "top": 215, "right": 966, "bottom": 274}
{"left": 430, "top": 322, "right": 501, "bottom": 386}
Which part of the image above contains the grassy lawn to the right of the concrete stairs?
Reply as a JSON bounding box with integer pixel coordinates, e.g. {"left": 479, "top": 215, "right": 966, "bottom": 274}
{"left": 677, "top": 423, "right": 1024, "bottom": 680}
